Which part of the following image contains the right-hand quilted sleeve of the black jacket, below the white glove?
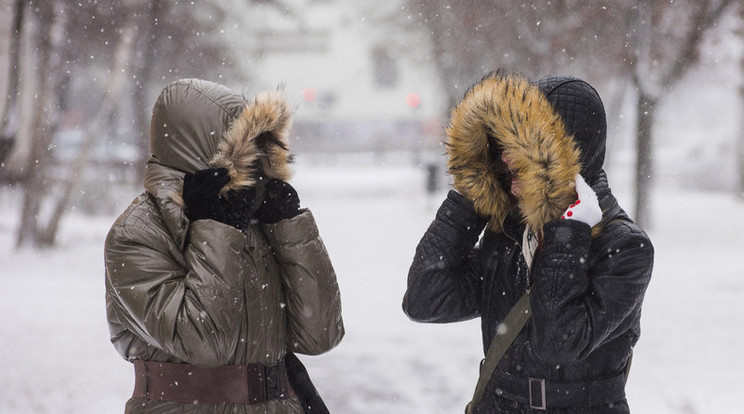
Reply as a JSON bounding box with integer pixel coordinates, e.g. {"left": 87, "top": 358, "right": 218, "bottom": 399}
{"left": 530, "top": 220, "right": 654, "bottom": 363}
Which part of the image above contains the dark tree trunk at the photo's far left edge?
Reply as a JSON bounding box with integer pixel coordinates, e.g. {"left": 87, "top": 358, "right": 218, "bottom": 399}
{"left": 0, "top": 0, "right": 26, "bottom": 165}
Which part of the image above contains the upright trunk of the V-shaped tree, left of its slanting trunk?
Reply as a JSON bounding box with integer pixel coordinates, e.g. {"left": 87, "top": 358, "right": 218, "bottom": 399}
{"left": 16, "top": 2, "right": 66, "bottom": 247}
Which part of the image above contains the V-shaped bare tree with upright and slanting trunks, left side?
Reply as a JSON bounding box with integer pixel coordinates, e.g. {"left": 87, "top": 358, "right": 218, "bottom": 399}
{"left": 16, "top": 0, "right": 139, "bottom": 247}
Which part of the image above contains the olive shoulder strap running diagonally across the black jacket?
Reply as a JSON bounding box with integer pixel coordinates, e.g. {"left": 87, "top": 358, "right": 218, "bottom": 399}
{"left": 468, "top": 293, "right": 532, "bottom": 407}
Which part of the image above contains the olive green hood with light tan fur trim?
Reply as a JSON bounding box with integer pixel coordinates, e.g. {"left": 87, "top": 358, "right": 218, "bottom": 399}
{"left": 150, "top": 79, "right": 292, "bottom": 192}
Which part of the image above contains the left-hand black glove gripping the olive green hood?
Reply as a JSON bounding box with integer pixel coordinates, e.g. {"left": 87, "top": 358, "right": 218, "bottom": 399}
{"left": 183, "top": 168, "right": 230, "bottom": 221}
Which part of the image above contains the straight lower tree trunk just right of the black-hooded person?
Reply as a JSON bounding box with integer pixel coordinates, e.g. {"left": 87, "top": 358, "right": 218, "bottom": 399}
{"left": 635, "top": 88, "right": 658, "bottom": 227}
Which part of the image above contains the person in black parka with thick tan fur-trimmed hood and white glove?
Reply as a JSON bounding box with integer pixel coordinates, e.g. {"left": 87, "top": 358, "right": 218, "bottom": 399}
{"left": 403, "top": 73, "right": 654, "bottom": 414}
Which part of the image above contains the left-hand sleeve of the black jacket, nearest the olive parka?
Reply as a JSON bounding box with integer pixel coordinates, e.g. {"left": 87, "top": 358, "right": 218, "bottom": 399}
{"left": 403, "top": 190, "right": 486, "bottom": 323}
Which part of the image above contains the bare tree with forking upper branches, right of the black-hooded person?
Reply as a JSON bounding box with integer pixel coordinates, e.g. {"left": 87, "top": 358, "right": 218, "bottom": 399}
{"left": 630, "top": 0, "right": 734, "bottom": 227}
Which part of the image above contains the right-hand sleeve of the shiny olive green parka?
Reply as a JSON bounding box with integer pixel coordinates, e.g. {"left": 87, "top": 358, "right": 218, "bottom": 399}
{"left": 263, "top": 209, "right": 344, "bottom": 355}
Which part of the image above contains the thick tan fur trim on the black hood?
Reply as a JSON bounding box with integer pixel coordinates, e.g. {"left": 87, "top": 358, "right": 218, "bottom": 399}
{"left": 446, "top": 74, "right": 580, "bottom": 232}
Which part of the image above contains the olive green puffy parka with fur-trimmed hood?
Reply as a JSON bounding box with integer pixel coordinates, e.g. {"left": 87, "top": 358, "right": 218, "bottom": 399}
{"left": 105, "top": 79, "right": 344, "bottom": 413}
